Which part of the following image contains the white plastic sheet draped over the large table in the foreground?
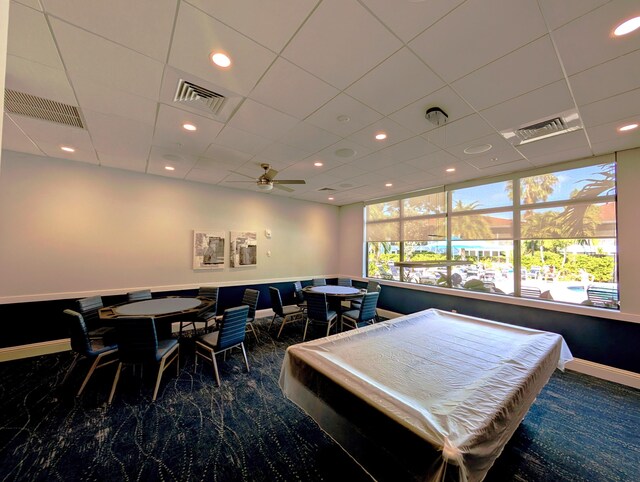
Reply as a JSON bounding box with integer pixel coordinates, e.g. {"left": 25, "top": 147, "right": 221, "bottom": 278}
{"left": 280, "top": 309, "right": 572, "bottom": 481}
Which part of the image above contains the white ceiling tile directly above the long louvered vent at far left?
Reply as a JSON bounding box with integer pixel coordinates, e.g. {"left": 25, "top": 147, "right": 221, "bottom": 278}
{"left": 5, "top": 55, "right": 78, "bottom": 106}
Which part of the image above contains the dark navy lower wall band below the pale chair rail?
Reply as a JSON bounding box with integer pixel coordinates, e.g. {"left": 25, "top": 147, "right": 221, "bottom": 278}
{"left": 0, "top": 279, "right": 640, "bottom": 373}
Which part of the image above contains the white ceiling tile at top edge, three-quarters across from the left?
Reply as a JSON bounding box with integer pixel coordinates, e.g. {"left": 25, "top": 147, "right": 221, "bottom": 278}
{"left": 409, "top": 0, "right": 547, "bottom": 82}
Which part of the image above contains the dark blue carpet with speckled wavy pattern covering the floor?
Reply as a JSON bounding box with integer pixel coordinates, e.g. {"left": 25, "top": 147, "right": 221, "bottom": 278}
{"left": 0, "top": 319, "right": 640, "bottom": 482}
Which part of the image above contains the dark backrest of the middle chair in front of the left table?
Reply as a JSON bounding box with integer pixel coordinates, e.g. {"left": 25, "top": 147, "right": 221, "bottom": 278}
{"left": 116, "top": 316, "right": 158, "bottom": 363}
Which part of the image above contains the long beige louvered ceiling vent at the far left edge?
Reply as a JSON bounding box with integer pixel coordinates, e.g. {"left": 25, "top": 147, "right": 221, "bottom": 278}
{"left": 4, "top": 89, "right": 84, "bottom": 129}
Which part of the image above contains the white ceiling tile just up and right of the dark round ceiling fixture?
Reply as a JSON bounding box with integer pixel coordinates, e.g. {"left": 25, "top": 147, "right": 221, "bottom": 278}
{"left": 453, "top": 36, "right": 563, "bottom": 110}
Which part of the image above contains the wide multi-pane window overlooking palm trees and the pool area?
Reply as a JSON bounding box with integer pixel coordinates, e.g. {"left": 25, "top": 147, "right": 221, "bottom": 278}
{"left": 366, "top": 158, "right": 619, "bottom": 309}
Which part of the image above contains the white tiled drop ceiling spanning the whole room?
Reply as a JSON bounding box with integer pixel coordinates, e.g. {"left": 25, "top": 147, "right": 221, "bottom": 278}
{"left": 2, "top": 0, "right": 640, "bottom": 205}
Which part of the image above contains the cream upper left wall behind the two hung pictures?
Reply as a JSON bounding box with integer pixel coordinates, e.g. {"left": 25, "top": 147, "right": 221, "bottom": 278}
{"left": 0, "top": 151, "right": 339, "bottom": 303}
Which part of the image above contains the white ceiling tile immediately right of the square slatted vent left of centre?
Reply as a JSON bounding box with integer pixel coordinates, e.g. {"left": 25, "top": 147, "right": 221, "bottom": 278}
{"left": 250, "top": 57, "right": 339, "bottom": 119}
